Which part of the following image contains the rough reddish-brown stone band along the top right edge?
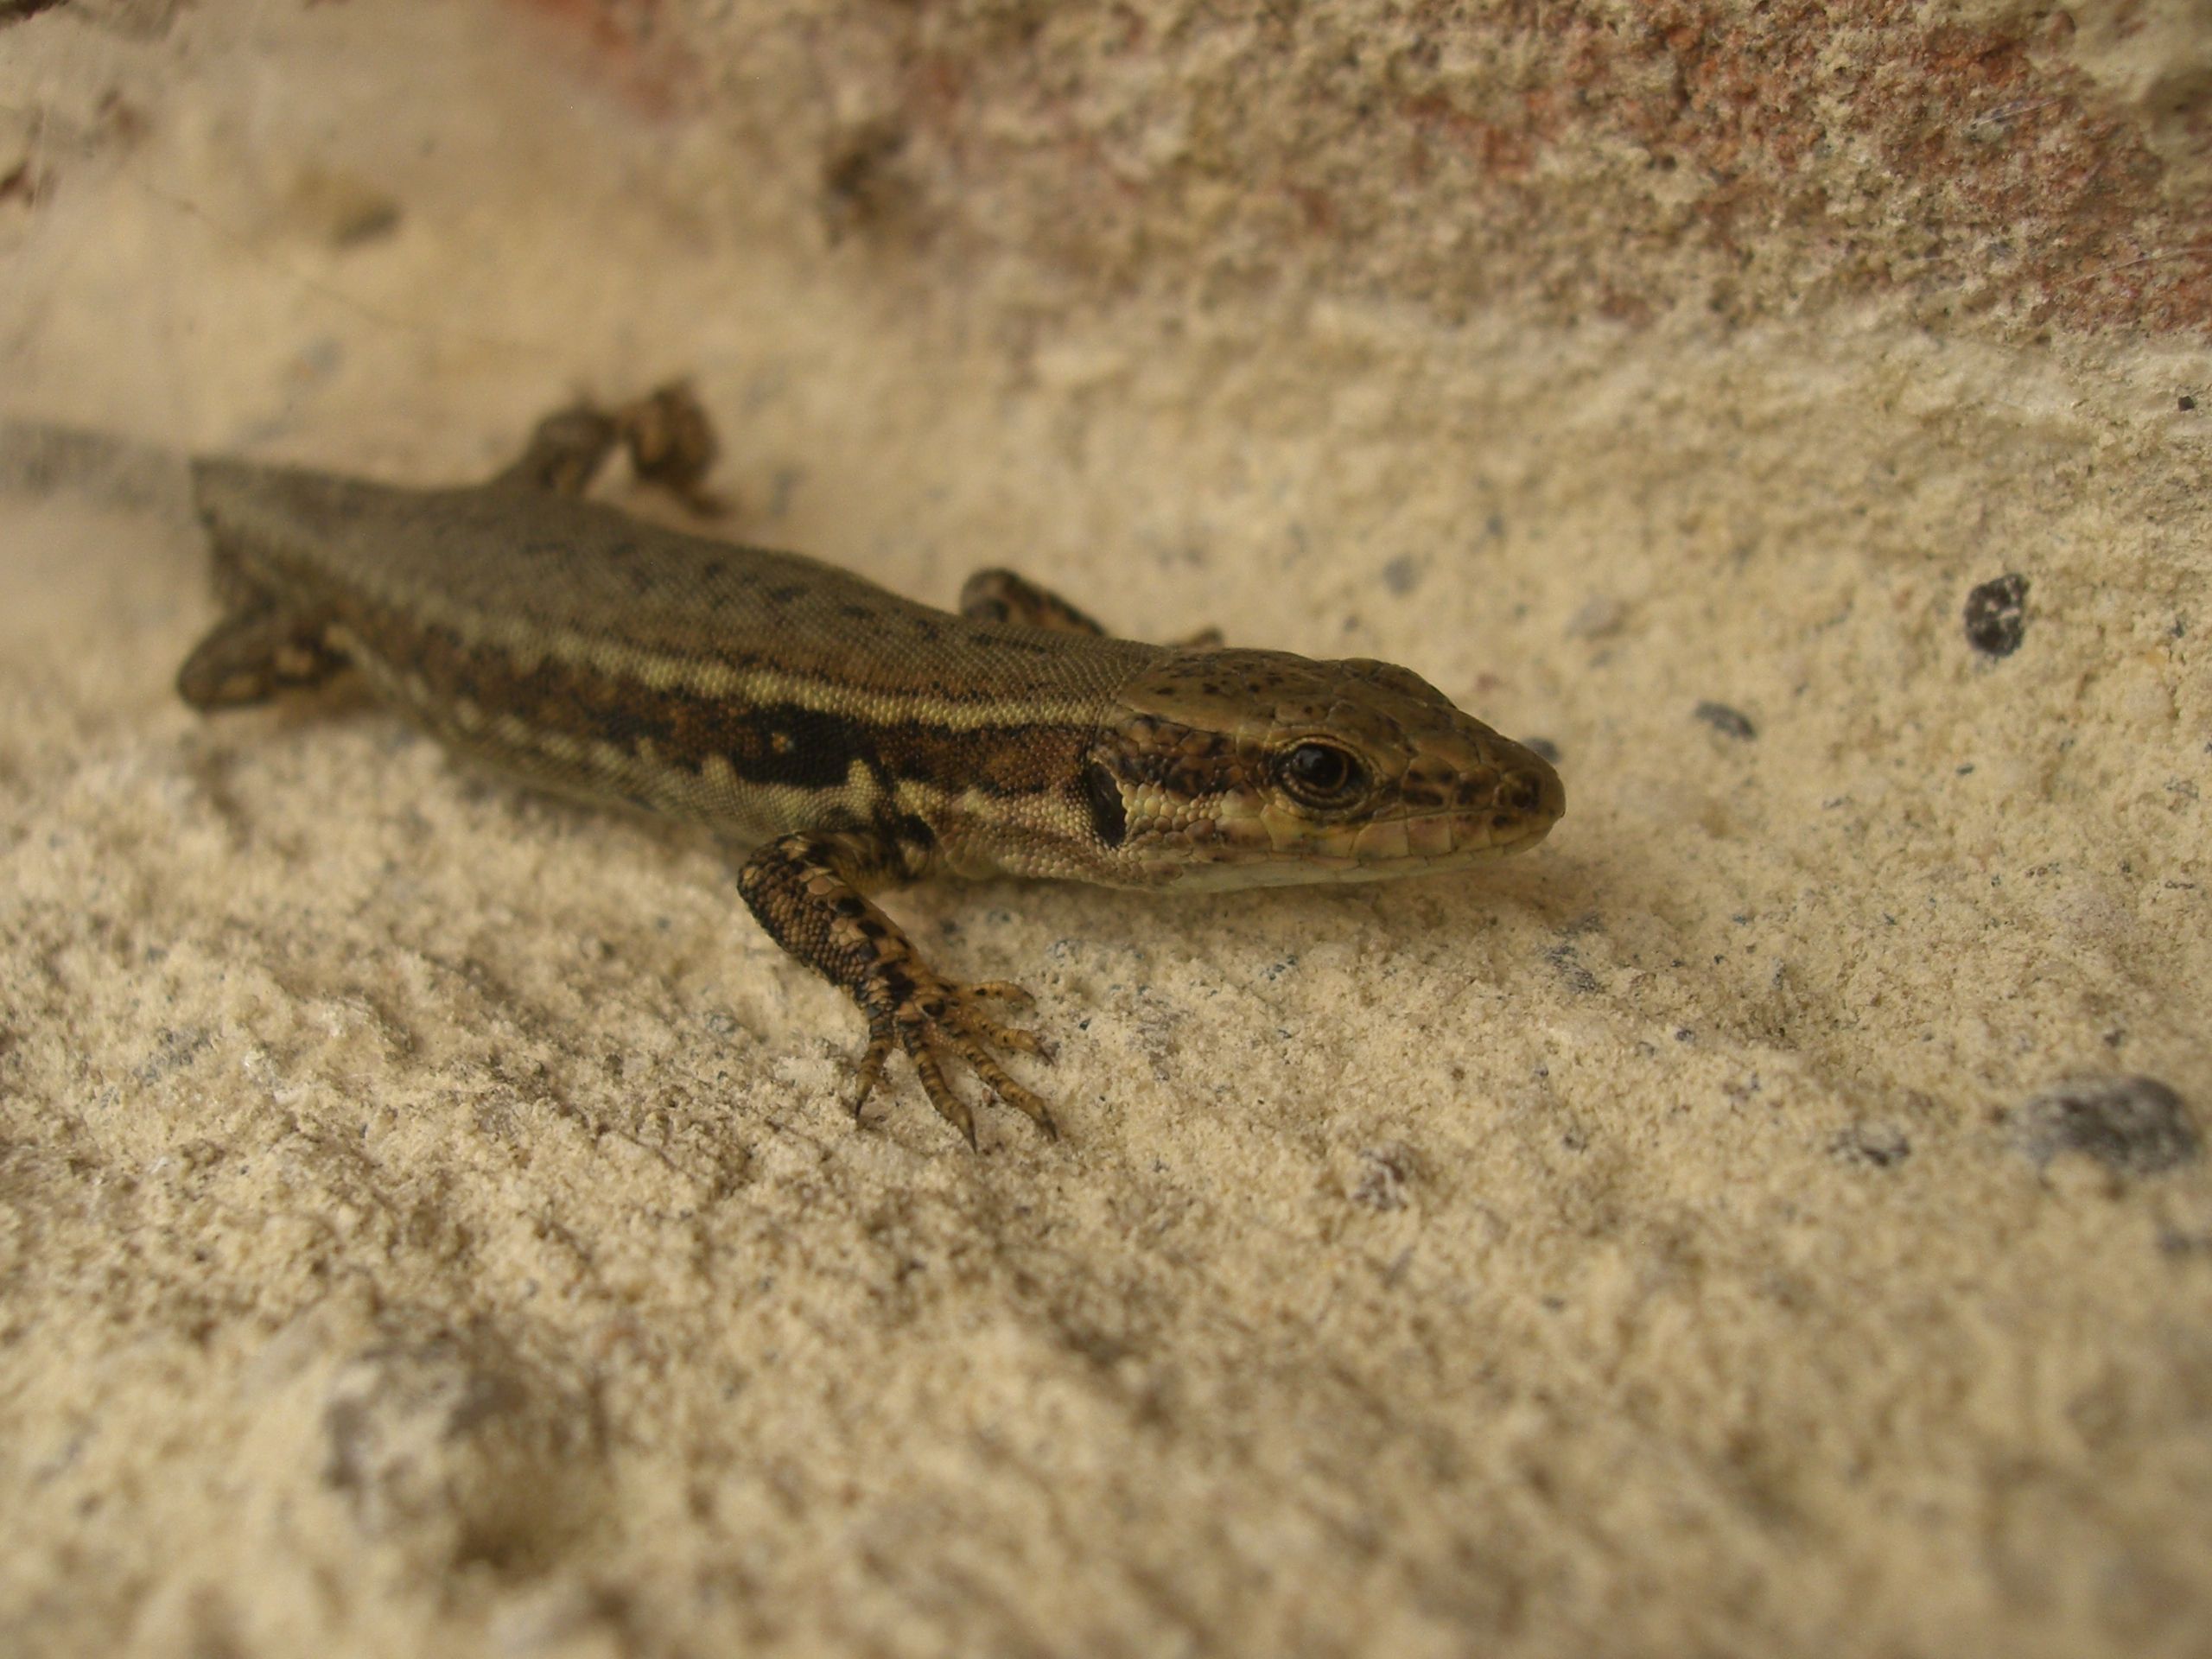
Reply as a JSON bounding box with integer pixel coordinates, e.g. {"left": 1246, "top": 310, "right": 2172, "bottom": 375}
{"left": 588, "top": 0, "right": 2212, "bottom": 336}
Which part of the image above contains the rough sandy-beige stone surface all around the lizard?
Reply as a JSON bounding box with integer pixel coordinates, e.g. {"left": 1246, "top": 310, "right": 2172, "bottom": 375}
{"left": 0, "top": 0, "right": 2212, "bottom": 1659}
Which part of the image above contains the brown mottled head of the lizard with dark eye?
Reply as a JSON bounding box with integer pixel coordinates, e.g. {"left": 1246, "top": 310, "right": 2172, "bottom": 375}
{"left": 1082, "top": 651, "right": 1566, "bottom": 889}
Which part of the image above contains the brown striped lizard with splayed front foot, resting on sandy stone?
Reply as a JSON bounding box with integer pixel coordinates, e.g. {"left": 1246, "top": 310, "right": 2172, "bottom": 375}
{"left": 163, "top": 383, "right": 1566, "bottom": 1148}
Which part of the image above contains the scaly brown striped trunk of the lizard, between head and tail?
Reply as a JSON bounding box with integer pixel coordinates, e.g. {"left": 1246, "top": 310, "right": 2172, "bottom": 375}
{"left": 193, "top": 460, "right": 1161, "bottom": 858}
